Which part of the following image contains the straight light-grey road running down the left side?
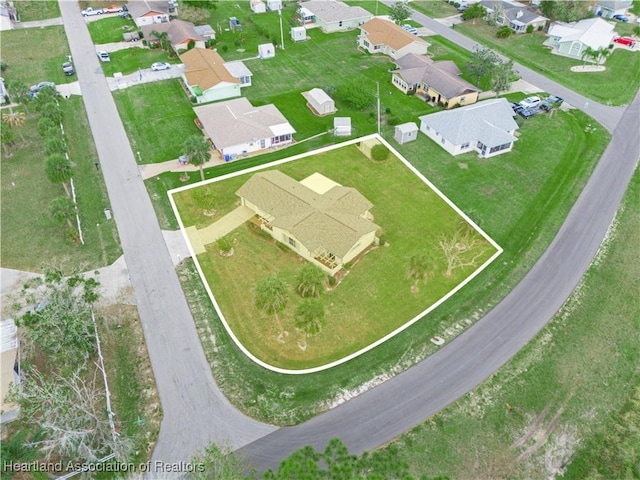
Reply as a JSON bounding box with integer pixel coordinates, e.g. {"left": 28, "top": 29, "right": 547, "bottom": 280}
{"left": 60, "top": 1, "right": 274, "bottom": 462}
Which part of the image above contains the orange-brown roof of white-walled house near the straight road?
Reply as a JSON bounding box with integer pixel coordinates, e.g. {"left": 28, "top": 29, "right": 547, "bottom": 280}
{"left": 180, "top": 48, "right": 240, "bottom": 92}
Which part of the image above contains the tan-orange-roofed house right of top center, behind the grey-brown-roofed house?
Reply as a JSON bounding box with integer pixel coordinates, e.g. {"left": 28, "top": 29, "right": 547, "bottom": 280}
{"left": 358, "top": 18, "right": 429, "bottom": 60}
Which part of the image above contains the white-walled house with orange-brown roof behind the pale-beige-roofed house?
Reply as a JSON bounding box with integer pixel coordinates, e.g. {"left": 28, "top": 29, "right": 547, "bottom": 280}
{"left": 180, "top": 48, "right": 241, "bottom": 103}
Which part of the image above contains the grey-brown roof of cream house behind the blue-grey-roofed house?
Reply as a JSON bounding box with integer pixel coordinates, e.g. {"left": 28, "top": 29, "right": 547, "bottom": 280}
{"left": 393, "top": 54, "right": 480, "bottom": 98}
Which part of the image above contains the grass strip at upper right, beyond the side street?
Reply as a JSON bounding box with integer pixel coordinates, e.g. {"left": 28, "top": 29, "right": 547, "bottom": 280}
{"left": 456, "top": 21, "right": 640, "bottom": 105}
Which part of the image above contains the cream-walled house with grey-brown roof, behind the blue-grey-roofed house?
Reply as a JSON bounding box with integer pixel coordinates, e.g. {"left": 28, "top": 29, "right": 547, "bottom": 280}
{"left": 391, "top": 53, "right": 480, "bottom": 108}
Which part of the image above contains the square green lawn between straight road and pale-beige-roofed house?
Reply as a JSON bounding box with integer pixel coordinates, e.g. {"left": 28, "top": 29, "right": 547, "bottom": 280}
{"left": 113, "top": 80, "right": 200, "bottom": 163}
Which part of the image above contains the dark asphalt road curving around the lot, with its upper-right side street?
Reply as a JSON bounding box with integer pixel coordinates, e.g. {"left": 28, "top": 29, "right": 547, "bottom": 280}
{"left": 239, "top": 14, "right": 640, "bottom": 471}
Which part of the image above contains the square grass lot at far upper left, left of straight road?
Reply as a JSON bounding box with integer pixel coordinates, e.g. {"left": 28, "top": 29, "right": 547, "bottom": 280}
{"left": 2, "top": 26, "right": 77, "bottom": 86}
